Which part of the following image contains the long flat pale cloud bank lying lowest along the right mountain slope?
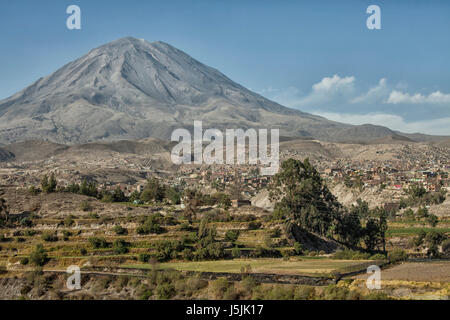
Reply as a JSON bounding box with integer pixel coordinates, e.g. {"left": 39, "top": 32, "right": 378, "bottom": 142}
{"left": 314, "top": 111, "right": 450, "bottom": 135}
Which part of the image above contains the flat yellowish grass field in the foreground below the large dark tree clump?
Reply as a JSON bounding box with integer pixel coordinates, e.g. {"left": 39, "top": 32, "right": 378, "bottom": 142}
{"left": 122, "top": 258, "right": 367, "bottom": 275}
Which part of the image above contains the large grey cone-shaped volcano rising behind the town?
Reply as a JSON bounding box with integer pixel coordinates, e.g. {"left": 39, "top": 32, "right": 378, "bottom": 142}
{"left": 0, "top": 37, "right": 442, "bottom": 144}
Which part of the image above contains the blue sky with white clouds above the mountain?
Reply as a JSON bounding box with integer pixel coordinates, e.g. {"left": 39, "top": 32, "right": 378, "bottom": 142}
{"left": 0, "top": 0, "right": 450, "bottom": 135}
